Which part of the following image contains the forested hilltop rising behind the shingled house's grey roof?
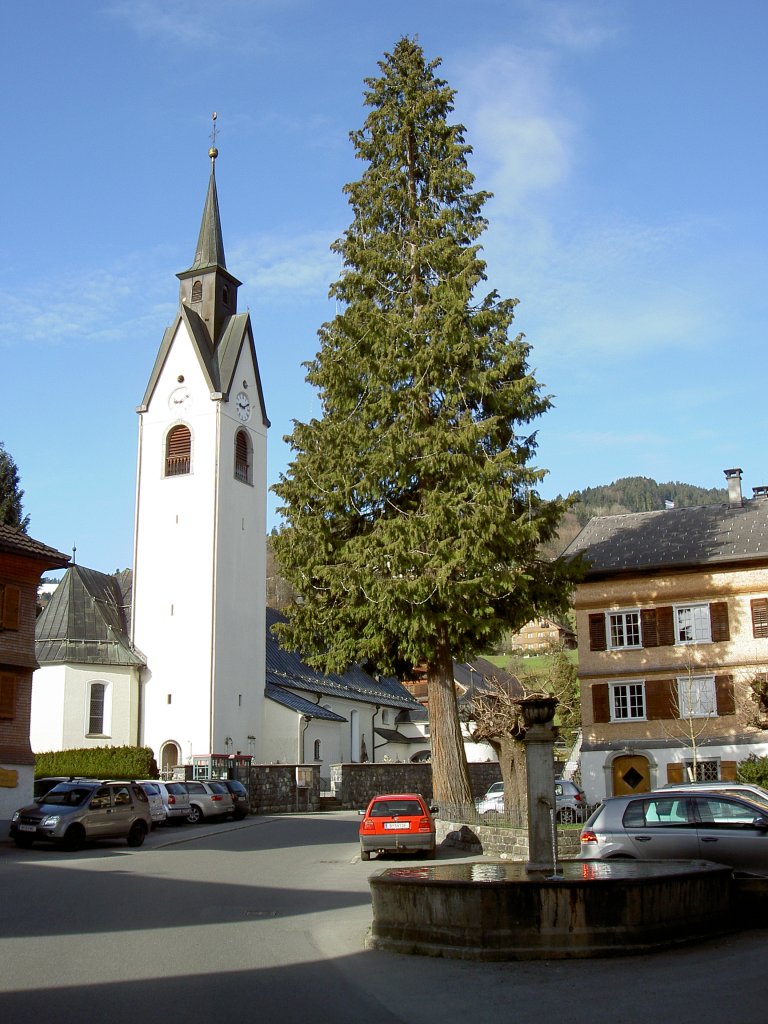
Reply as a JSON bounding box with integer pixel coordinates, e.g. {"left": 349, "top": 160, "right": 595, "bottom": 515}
{"left": 547, "top": 476, "right": 728, "bottom": 555}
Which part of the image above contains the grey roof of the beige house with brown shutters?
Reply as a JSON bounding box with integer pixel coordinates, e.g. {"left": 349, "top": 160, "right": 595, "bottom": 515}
{"left": 563, "top": 497, "right": 768, "bottom": 580}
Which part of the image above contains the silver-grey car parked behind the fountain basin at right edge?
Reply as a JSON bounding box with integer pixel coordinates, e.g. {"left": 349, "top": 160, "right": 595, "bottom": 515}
{"left": 579, "top": 790, "right": 768, "bottom": 874}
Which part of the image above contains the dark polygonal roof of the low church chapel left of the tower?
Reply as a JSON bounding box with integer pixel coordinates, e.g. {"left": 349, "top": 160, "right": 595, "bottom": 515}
{"left": 35, "top": 565, "right": 146, "bottom": 666}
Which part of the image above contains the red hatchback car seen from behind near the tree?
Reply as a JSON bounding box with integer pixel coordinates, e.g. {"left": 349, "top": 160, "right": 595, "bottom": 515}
{"left": 359, "top": 793, "right": 437, "bottom": 860}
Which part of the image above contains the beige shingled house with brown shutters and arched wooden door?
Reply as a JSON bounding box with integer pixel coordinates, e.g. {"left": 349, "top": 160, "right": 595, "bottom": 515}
{"left": 566, "top": 469, "right": 768, "bottom": 802}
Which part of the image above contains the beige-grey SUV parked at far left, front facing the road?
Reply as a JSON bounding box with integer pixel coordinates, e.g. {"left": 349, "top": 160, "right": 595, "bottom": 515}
{"left": 10, "top": 779, "right": 152, "bottom": 850}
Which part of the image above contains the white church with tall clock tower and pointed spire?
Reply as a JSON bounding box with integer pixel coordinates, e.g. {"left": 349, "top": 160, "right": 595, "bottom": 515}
{"left": 31, "top": 138, "right": 429, "bottom": 776}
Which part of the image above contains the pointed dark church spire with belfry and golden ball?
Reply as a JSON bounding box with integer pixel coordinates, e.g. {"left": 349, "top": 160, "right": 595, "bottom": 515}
{"left": 176, "top": 114, "right": 241, "bottom": 347}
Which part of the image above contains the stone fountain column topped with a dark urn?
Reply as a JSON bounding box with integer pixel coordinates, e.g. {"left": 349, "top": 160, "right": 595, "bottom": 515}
{"left": 519, "top": 695, "right": 558, "bottom": 874}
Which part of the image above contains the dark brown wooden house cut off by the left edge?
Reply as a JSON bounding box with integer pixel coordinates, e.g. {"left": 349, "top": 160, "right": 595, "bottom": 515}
{"left": 0, "top": 525, "right": 70, "bottom": 818}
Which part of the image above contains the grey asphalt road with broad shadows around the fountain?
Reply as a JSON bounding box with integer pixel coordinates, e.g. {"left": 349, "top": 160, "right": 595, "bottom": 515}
{"left": 0, "top": 813, "right": 768, "bottom": 1024}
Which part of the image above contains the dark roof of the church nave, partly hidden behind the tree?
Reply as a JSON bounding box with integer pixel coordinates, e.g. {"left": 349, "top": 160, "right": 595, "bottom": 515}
{"left": 266, "top": 608, "right": 419, "bottom": 711}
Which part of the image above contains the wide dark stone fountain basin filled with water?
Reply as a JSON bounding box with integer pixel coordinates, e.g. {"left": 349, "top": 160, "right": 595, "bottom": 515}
{"left": 366, "top": 860, "right": 732, "bottom": 961}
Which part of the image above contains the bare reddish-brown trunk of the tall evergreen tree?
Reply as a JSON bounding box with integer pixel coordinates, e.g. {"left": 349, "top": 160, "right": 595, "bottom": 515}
{"left": 427, "top": 627, "right": 472, "bottom": 808}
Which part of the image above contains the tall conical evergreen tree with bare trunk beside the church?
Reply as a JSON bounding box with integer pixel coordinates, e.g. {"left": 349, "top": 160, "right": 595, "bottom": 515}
{"left": 274, "top": 38, "right": 581, "bottom": 806}
